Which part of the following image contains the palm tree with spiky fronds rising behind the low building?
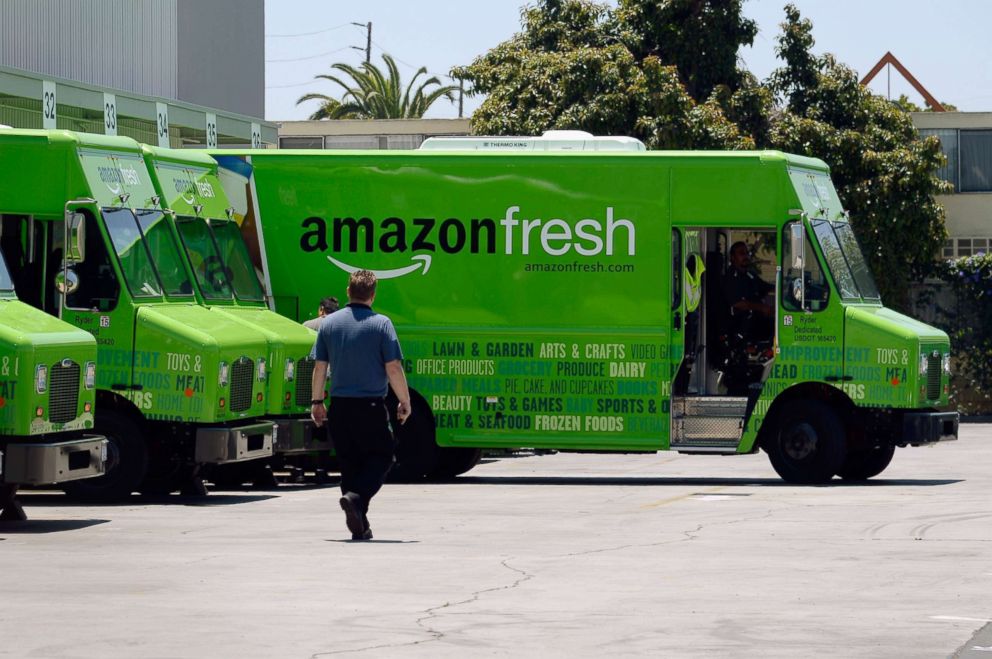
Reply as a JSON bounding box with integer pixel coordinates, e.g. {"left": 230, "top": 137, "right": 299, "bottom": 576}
{"left": 296, "top": 53, "right": 458, "bottom": 119}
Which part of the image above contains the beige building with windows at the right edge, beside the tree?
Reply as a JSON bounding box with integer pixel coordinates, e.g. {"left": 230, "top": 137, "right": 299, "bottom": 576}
{"left": 912, "top": 112, "right": 992, "bottom": 258}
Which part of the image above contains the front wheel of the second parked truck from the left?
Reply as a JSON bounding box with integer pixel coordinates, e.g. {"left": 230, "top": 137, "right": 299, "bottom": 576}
{"left": 62, "top": 411, "right": 148, "bottom": 501}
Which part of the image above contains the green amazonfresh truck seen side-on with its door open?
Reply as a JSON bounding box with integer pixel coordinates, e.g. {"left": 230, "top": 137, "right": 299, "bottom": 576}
{"left": 213, "top": 136, "right": 958, "bottom": 483}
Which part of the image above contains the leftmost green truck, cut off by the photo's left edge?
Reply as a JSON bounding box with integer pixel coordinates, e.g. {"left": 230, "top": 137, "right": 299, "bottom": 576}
{"left": 0, "top": 248, "right": 107, "bottom": 521}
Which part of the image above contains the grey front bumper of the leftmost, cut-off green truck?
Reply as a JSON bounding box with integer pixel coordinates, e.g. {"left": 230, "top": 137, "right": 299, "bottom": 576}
{"left": 0, "top": 435, "right": 107, "bottom": 485}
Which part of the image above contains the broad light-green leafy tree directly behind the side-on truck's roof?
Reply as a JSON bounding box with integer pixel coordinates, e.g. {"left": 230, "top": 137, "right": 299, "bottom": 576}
{"left": 452, "top": 0, "right": 753, "bottom": 149}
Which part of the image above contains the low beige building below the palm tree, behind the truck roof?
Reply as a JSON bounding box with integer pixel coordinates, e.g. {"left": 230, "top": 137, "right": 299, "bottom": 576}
{"left": 278, "top": 119, "right": 469, "bottom": 149}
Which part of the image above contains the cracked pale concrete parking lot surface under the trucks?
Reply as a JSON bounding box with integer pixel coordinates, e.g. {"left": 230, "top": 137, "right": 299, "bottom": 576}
{"left": 0, "top": 424, "right": 992, "bottom": 658}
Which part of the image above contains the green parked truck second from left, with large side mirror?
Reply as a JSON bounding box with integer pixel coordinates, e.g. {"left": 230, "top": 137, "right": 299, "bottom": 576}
{"left": 0, "top": 130, "right": 273, "bottom": 499}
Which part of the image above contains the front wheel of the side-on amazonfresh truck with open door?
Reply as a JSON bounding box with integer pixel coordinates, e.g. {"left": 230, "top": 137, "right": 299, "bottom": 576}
{"left": 765, "top": 400, "right": 847, "bottom": 484}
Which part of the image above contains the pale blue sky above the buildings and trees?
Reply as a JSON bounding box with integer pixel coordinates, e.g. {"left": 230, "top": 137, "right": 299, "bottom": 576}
{"left": 265, "top": 0, "right": 992, "bottom": 121}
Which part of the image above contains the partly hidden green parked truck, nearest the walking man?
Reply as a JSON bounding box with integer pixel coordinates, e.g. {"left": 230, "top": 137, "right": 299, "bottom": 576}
{"left": 142, "top": 146, "right": 330, "bottom": 462}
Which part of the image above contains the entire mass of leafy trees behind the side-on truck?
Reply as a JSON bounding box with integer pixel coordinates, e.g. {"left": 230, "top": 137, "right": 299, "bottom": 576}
{"left": 453, "top": 0, "right": 948, "bottom": 308}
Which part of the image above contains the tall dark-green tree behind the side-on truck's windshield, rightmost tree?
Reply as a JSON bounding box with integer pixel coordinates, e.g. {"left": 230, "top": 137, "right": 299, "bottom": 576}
{"left": 768, "top": 5, "right": 949, "bottom": 309}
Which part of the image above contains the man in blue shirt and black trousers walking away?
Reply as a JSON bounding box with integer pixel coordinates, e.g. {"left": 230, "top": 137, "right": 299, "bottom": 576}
{"left": 310, "top": 270, "right": 411, "bottom": 540}
